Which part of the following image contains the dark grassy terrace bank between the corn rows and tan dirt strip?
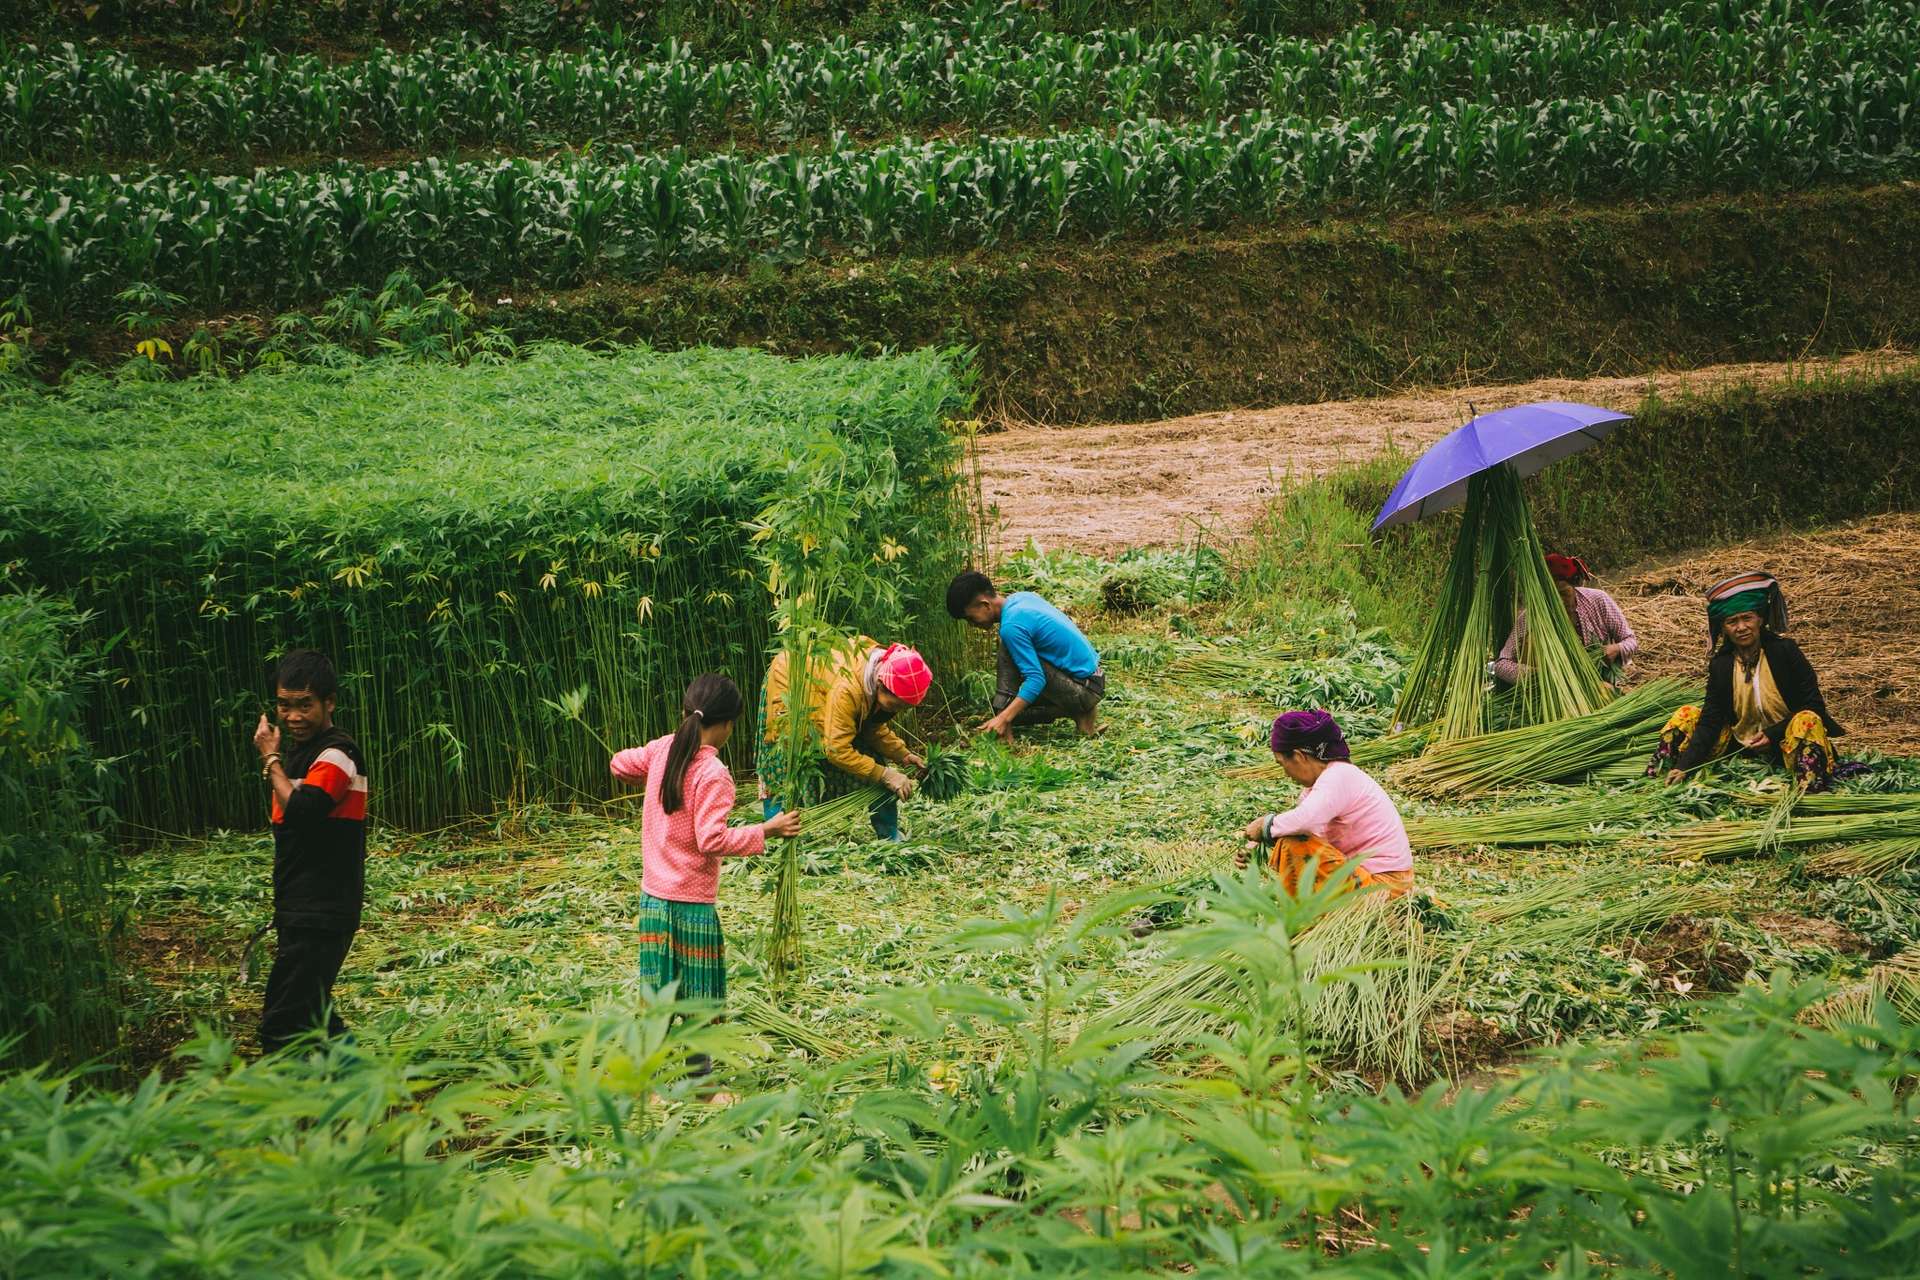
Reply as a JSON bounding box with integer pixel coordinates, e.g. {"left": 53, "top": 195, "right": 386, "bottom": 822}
{"left": 33, "top": 186, "right": 1920, "bottom": 422}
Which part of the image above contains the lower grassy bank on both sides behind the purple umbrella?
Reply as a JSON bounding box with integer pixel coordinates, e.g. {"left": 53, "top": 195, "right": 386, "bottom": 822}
{"left": 1236, "top": 358, "right": 1920, "bottom": 641}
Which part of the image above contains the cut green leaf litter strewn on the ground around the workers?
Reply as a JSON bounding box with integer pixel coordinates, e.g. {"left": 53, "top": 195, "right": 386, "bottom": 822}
{"left": 125, "top": 606, "right": 1920, "bottom": 1082}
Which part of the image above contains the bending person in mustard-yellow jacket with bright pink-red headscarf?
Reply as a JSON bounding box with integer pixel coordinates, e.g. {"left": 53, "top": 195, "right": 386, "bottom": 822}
{"left": 758, "top": 635, "right": 933, "bottom": 841}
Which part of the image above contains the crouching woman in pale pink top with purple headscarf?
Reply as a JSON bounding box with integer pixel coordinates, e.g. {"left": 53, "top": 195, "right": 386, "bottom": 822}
{"left": 1235, "top": 712, "right": 1413, "bottom": 898}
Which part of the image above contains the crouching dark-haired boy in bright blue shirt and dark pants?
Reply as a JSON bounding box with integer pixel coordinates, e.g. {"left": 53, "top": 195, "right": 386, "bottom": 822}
{"left": 947, "top": 570, "right": 1106, "bottom": 743}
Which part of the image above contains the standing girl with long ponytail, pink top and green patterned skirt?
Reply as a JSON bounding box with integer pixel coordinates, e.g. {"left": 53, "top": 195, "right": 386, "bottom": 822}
{"left": 612, "top": 676, "right": 801, "bottom": 1075}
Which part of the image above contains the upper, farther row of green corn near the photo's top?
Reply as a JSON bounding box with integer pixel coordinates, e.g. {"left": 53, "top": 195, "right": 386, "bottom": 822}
{"left": 0, "top": 0, "right": 1920, "bottom": 163}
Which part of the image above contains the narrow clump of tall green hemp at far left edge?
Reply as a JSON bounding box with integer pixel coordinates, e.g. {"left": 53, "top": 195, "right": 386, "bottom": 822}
{"left": 0, "top": 593, "right": 119, "bottom": 1063}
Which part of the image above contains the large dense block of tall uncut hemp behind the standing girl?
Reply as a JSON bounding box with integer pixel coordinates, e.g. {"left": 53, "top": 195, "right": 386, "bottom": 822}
{"left": 0, "top": 347, "right": 972, "bottom": 831}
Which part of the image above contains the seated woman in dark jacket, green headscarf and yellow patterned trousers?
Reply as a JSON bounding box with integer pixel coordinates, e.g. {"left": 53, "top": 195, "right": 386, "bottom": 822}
{"left": 1647, "top": 574, "right": 1845, "bottom": 791}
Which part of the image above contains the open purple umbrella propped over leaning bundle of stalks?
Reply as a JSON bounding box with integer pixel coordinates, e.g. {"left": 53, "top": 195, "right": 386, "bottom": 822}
{"left": 1373, "top": 399, "right": 1630, "bottom": 530}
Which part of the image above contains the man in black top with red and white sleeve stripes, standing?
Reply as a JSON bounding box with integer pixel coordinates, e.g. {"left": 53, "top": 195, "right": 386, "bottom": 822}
{"left": 253, "top": 649, "right": 367, "bottom": 1054}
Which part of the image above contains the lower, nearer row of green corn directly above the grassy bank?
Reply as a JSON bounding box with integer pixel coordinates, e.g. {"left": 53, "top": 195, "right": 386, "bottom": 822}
{"left": 0, "top": 67, "right": 1920, "bottom": 313}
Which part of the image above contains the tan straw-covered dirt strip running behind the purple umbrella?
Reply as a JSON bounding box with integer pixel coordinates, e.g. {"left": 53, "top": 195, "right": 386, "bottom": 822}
{"left": 979, "top": 351, "right": 1920, "bottom": 553}
